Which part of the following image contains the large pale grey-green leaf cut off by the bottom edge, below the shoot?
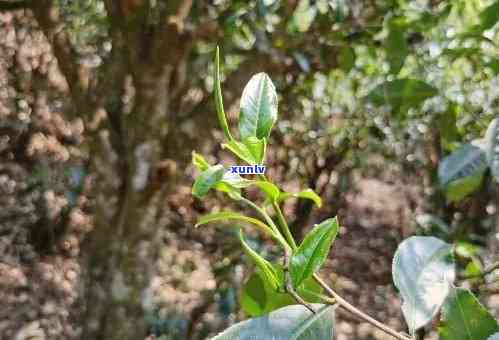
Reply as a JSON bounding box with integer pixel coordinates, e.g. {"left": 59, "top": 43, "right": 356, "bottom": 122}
{"left": 211, "top": 305, "right": 335, "bottom": 340}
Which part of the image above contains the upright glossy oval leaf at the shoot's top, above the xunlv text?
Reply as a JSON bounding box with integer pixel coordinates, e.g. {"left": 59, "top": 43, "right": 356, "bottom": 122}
{"left": 239, "top": 73, "right": 277, "bottom": 140}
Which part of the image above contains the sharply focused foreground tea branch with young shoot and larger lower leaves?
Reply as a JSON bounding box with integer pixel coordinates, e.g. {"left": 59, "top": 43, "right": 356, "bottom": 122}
{"left": 192, "top": 48, "right": 499, "bottom": 340}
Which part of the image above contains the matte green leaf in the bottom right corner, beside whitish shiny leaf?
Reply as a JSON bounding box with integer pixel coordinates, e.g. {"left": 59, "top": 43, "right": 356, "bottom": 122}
{"left": 439, "top": 288, "right": 499, "bottom": 340}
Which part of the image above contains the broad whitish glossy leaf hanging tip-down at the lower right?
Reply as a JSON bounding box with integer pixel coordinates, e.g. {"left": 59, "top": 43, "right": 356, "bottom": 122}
{"left": 392, "top": 236, "right": 456, "bottom": 335}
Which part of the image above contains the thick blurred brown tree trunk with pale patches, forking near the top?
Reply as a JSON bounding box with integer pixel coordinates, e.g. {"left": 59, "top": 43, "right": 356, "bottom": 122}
{"left": 33, "top": 0, "right": 192, "bottom": 340}
